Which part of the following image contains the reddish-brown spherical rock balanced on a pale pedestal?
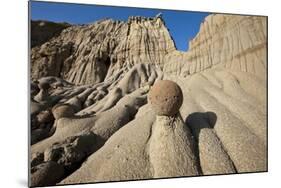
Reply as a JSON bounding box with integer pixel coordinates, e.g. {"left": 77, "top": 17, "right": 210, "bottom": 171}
{"left": 148, "top": 80, "right": 183, "bottom": 116}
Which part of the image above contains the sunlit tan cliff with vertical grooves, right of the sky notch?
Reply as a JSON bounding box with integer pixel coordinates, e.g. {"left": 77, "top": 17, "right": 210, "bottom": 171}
{"left": 164, "top": 14, "right": 267, "bottom": 79}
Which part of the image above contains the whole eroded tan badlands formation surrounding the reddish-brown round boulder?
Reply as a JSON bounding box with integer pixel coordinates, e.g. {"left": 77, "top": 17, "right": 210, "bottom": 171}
{"left": 30, "top": 14, "right": 267, "bottom": 186}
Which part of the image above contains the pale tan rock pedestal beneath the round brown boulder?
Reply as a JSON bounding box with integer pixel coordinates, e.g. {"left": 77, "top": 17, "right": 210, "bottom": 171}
{"left": 149, "top": 114, "right": 200, "bottom": 178}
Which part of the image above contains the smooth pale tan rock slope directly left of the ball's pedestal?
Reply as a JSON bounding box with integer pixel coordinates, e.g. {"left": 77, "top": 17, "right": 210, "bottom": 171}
{"left": 59, "top": 108, "right": 155, "bottom": 184}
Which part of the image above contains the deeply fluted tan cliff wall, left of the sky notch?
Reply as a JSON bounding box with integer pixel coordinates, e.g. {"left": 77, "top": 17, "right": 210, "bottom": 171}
{"left": 31, "top": 17, "right": 175, "bottom": 84}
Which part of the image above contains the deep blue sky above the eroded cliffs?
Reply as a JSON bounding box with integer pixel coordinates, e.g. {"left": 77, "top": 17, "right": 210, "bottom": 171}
{"left": 31, "top": 1, "right": 209, "bottom": 51}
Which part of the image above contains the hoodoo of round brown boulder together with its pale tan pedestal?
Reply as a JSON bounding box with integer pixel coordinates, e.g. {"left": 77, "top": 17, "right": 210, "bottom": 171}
{"left": 149, "top": 80, "right": 199, "bottom": 178}
